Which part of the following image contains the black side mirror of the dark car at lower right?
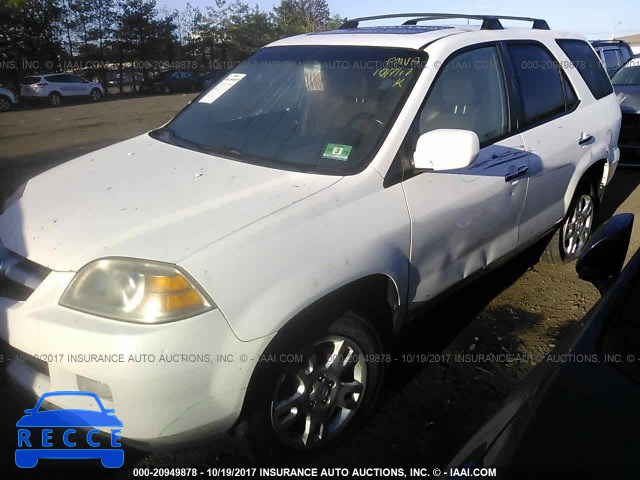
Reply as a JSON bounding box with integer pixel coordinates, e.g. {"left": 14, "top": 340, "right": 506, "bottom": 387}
{"left": 576, "top": 213, "right": 634, "bottom": 295}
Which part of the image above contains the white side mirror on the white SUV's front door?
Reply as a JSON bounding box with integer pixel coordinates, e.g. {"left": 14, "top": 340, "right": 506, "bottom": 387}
{"left": 413, "top": 129, "right": 480, "bottom": 171}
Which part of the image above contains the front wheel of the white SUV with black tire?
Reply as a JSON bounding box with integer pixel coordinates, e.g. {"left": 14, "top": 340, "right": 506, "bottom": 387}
{"left": 248, "top": 311, "right": 383, "bottom": 460}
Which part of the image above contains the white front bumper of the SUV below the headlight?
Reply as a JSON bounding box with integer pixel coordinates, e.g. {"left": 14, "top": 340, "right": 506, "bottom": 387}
{"left": 0, "top": 272, "right": 272, "bottom": 446}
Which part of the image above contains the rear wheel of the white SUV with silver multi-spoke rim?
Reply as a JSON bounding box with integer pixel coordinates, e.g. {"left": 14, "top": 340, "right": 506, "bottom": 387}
{"left": 542, "top": 179, "right": 598, "bottom": 264}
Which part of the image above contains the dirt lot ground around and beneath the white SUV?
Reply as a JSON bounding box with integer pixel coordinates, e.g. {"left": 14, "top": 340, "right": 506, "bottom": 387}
{"left": 0, "top": 95, "right": 640, "bottom": 478}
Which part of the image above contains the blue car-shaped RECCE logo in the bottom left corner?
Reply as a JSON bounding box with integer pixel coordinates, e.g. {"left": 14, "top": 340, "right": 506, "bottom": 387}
{"left": 16, "top": 392, "right": 124, "bottom": 468}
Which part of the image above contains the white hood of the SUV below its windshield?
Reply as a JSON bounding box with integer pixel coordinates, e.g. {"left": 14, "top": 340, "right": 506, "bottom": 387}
{"left": 0, "top": 134, "right": 342, "bottom": 271}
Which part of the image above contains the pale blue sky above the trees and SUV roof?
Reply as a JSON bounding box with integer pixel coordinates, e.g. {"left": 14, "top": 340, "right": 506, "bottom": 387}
{"left": 156, "top": 0, "right": 640, "bottom": 39}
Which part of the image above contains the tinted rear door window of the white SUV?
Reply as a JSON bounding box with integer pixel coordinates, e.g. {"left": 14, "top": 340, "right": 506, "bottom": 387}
{"left": 507, "top": 43, "right": 565, "bottom": 125}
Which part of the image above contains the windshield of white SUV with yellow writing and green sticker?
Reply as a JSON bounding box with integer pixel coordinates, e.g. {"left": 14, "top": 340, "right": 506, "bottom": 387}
{"left": 153, "top": 46, "right": 426, "bottom": 175}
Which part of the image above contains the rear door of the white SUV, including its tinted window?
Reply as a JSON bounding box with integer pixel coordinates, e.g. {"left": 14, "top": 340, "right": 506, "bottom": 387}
{"left": 506, "top": 41, "right": 602, "bottom": 243}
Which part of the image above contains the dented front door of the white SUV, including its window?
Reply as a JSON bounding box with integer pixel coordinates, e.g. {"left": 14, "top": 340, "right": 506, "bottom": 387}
{"left": 402, "top": 44, "right": 529, "bottom": 303}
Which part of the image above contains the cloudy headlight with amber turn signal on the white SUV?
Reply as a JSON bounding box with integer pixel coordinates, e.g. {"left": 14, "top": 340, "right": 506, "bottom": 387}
{"left": 60, "top": 258, "right": 212, "bottom": 324}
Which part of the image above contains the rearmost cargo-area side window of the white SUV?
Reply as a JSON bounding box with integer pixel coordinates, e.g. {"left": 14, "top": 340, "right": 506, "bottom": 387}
{"left": 556, "top": 40, "right": 613, "bottom": 100}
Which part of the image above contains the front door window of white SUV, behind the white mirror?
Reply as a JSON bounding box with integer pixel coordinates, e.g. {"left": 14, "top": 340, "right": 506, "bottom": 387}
{"left": 420, "top": 46, "right": 509, "bottom": 144}
